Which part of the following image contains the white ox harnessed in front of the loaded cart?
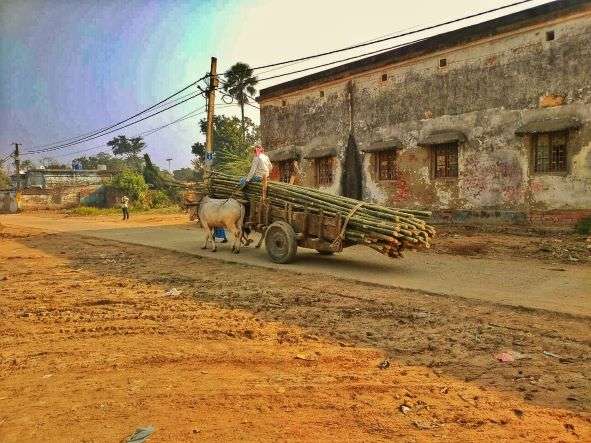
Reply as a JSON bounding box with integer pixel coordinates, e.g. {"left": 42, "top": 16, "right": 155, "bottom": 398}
{"left": 191, "top": 196, "right": 246, "bottom": 254}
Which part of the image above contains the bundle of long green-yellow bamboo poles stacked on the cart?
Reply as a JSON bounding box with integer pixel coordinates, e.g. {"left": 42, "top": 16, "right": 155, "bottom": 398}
{"left": 199, "top": 172, "right": 435, "bottom": 257}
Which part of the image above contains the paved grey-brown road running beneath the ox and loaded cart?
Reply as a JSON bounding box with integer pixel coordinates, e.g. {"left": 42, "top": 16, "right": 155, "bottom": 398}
{"left": 0, "top": 214, "right": 591, "bottom": 315}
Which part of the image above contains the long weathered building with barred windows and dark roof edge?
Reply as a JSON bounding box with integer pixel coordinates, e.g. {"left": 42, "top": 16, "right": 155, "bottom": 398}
{"left": 259, "top": 0, "right": 591, "bottom": 223}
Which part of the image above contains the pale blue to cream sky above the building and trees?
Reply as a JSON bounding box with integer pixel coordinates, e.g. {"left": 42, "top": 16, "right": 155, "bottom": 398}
{"left": 0, "top": 0, "right": 548, "bottom": 173}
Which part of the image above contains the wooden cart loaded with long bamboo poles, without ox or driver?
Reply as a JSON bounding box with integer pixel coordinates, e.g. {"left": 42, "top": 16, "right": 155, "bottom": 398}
{"left": 202, "top": 172, "right": 435, "bottom": 263}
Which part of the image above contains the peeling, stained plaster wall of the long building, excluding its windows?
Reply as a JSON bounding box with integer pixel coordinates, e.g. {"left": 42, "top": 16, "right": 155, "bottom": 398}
{"left": 261, "top": 14, "right": 591, "bottom": 222}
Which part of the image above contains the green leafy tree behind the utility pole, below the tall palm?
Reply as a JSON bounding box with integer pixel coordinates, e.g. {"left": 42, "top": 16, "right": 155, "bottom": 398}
{"left": 191, "top": 115, "right": 260, "bottom": 175}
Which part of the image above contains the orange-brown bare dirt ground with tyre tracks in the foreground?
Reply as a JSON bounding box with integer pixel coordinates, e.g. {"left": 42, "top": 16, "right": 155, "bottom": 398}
{"left": 0, "top": 228, "right": 591, "bottom": 442}
